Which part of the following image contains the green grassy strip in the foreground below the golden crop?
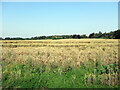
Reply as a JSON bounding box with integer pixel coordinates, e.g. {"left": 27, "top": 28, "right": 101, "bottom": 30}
{"left": 2, "top": 61, "right": 118, "bottom": 88}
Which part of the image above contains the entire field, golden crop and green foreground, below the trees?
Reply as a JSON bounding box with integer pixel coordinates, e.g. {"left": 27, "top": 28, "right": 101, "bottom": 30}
{"left": 0, "top": 39, "right": 120, "bottom": 88}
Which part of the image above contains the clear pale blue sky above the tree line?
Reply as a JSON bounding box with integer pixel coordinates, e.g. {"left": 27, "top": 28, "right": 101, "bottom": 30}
{"left": 2, "top": 2, "right": 118, "bottom": 37}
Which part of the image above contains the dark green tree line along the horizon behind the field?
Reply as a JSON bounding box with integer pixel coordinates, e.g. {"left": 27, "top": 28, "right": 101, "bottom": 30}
{"left": 0, "top": 29, "right": 120, "bottom": 40}
